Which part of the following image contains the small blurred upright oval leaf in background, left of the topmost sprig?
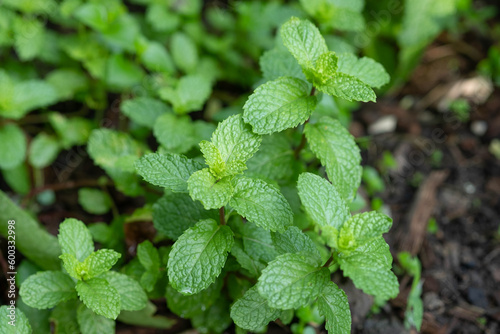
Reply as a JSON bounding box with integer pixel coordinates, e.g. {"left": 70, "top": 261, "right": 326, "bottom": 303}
{"left": 170, "top": 32, "right": 198, "bottom": 73}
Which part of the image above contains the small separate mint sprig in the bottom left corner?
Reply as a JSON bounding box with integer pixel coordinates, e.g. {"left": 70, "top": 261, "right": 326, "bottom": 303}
{"left": 19, "top": 218, "right": 147, "bottom": 333}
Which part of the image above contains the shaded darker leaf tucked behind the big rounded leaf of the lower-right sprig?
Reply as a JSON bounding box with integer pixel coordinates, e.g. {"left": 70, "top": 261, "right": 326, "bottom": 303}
{"left": 271, "top": 226, "right": 321, "bottom": 261}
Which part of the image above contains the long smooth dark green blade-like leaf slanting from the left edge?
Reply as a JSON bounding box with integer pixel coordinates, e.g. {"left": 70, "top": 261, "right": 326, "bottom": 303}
{"left": 0, "top": 190, "right": 61, "bottom": 270}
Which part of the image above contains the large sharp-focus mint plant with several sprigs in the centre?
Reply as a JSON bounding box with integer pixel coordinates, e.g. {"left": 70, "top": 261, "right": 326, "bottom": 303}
{"left": 135, "top": 17, "right": 399, "bottom": 333}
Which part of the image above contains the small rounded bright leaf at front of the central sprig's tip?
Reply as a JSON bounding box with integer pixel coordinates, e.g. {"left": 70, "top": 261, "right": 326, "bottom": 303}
{"left": 188, "top": 168, "right": 233, "bottom": 210}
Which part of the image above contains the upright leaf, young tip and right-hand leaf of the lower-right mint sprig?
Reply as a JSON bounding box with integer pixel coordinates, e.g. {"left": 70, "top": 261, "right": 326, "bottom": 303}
{"left": 297, "top": 173, "right": 399, "bottom": 299}
